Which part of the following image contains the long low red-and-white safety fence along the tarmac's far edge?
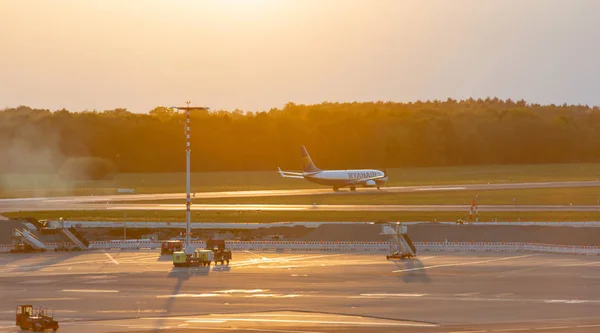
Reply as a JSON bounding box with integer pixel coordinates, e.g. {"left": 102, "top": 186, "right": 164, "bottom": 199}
{"left": 90, "top": 239, "right": 600, "bottom": 255}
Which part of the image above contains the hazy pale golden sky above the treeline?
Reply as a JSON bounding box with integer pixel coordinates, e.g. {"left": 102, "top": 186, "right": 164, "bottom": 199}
{"left": 0, "top": 0, "right": 600, "bottom": 112}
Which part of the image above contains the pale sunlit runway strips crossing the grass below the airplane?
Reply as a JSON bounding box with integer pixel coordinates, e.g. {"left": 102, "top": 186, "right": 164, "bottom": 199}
{"left": 0, "top": 181, "right": 600, "bottom": 213}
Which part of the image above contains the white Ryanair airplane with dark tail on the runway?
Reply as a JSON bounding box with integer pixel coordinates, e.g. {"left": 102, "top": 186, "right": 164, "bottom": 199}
{"left": 277, "top": 146, "right": 388, "bottom": 192}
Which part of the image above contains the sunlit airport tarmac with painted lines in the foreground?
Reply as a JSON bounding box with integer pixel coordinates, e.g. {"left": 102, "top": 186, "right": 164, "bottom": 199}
{"left": 0, "top": 250, "right": 600, "bottom": 333}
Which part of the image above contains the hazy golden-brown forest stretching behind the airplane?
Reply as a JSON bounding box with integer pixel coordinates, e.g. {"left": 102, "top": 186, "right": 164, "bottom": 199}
{"left": 0, "top": 98, "right": 600, "bottom": 173}
